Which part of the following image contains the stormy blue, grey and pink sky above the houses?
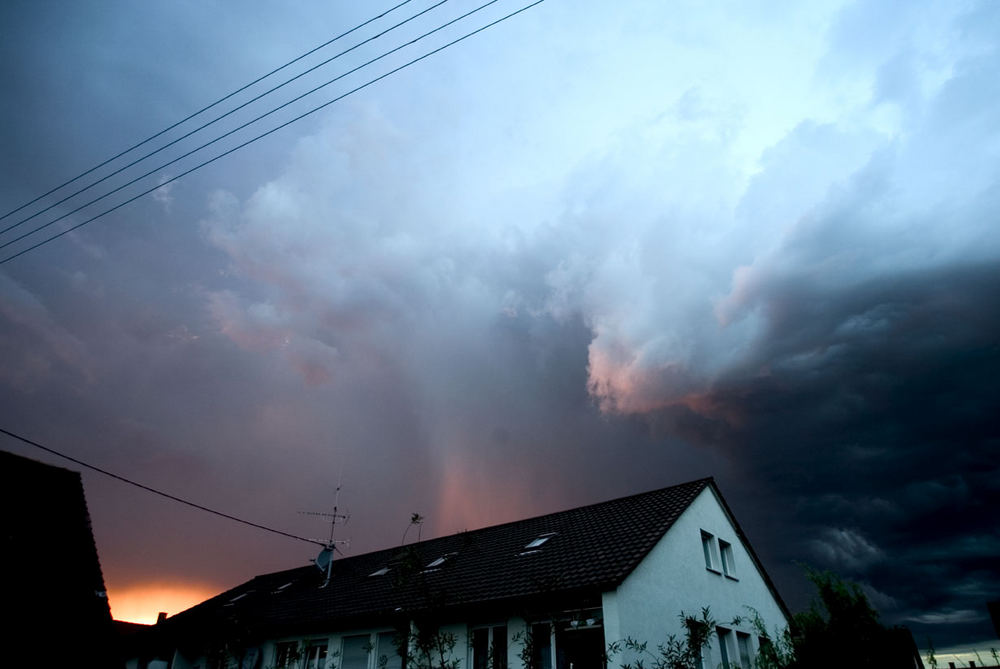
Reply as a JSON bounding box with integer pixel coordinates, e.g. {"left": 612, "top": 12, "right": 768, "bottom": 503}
{"left": 0, "top": 0, "right": 1000, "bottom": 647}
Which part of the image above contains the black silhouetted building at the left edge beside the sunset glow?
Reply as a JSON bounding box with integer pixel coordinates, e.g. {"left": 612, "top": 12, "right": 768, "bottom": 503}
{"left": 0, "top": 451, "right": 122, "bottom": 667}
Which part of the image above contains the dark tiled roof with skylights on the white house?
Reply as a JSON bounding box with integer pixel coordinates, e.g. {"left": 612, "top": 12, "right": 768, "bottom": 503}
{"left": 164, "top": 479, "right": 712, "bottom": 631}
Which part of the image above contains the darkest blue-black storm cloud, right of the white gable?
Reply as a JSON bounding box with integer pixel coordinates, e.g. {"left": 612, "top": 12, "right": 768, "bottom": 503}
{"left": 712, "top": 264, "right": 1000, "bottom": 637}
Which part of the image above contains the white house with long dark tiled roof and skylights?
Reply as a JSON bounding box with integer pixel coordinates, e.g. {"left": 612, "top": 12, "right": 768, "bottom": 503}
{"left": 130, "top": 479, "right": 788, "bottom": 669}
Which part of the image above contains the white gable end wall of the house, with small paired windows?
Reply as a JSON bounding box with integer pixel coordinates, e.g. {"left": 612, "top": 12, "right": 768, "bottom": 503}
{"left": 603, "top": 487, "right": 787, "bottom": 669}
